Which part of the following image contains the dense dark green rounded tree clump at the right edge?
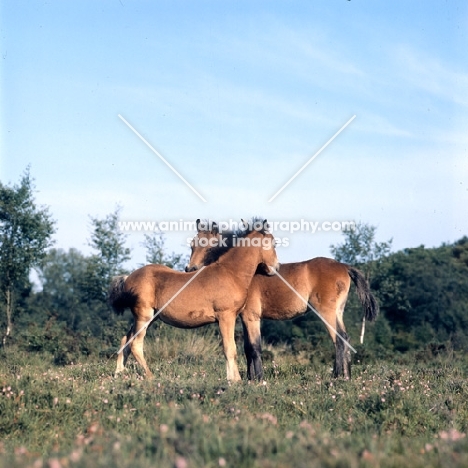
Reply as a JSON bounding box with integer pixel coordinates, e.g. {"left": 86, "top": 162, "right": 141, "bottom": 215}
{"left": 373, "top": 245, "right": 468, "bottom": 351}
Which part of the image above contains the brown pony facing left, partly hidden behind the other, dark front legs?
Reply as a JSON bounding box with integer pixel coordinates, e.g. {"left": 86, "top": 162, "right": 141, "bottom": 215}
{"left": 185, "top": 220, "right": 379, "bottom": 379}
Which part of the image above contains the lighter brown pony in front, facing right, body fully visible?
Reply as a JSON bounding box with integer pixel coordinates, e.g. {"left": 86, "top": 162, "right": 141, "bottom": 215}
{"left": 109, "top": 219, "right": 278, "bottom": 380}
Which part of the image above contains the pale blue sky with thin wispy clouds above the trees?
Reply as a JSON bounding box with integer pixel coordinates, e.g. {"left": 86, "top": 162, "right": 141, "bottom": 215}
{"left": 0, "top": 0, "right": 468, "bottom": 265}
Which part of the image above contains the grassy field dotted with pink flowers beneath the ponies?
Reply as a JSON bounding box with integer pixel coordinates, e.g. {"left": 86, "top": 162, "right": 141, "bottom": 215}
{"left": 0, "top": 327, "right": 468, "bottom": 468}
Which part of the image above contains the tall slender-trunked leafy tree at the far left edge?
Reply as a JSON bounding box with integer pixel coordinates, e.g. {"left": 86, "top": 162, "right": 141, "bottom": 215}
{"left": 0, "top": 168, "right": 55, "bottom": 345}
